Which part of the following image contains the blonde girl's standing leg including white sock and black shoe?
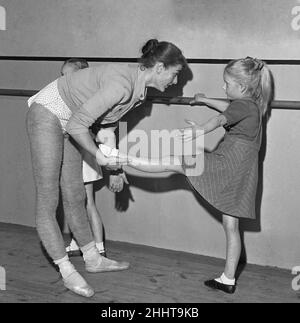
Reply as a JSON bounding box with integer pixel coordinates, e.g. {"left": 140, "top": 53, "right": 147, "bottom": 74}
{"left": 205, "top": 214, "right": 241, "bottom": 294}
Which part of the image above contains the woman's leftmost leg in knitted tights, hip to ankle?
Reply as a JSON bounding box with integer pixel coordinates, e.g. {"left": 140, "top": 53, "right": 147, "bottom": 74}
{"left": 26, "top": 104, "right": 66, "bottom": 260}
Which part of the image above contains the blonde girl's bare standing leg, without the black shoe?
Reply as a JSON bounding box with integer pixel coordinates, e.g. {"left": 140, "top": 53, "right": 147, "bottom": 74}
{"left": 223, "top": 214, "right": 241, "bottom": 279}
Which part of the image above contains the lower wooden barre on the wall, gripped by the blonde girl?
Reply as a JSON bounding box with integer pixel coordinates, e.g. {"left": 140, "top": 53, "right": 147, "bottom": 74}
{"left": 0, "top": 89, "right": 300, "bottom": 110}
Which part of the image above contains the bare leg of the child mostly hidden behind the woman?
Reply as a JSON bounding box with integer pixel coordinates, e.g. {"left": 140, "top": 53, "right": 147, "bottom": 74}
{"left": 84, "top": 182, "right": 103, "bottom": 243}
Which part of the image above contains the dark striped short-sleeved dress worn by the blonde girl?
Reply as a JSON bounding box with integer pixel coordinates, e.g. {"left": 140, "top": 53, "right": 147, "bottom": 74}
{"left": 188, "top": 99, "right": 262, "bottom": 219}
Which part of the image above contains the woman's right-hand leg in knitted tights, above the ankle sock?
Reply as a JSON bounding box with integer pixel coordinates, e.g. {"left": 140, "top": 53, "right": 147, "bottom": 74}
{"left": 61, "top": 138, "right": 93, "bottom": 247}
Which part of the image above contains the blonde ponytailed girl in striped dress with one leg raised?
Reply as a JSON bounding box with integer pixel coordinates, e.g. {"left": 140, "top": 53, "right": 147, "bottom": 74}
{"left": 106, "top": 57, "right": 273, "bottom": 293}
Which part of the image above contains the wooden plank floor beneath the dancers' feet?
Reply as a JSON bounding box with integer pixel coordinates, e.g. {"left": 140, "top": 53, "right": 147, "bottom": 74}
{"left": 0, "top": 223, "right": 300, "bottom": 303}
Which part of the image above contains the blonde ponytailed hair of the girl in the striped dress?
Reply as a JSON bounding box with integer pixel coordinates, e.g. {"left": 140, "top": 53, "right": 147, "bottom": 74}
{"left": 224, "top": 57, "right": 274, "bottom": 115}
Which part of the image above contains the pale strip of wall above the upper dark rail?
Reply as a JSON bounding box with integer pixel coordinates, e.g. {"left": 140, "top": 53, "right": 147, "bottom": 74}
{"left": 0, "top": 0, "right": 300, "bottom": 59}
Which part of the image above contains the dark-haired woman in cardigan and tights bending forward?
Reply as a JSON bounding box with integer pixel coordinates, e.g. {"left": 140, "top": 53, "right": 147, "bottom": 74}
{"left": 27, "top": 39, "right": 186, "bottom": 297}
